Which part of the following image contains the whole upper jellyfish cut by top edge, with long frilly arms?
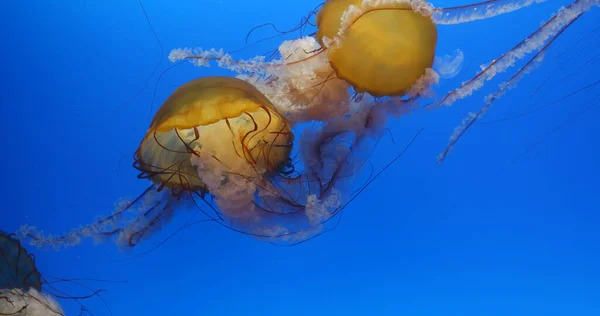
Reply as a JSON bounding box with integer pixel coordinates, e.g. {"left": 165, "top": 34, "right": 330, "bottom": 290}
{"left": 169, "top": 0, "right": 600, "bottom": 162}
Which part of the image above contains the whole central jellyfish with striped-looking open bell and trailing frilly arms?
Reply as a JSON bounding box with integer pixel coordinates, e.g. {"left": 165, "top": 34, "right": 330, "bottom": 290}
{"left": 21, "top": 77, "right": 390, "bottom": 248}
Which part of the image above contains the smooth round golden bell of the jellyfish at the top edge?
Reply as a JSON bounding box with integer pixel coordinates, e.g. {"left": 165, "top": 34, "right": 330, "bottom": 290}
{"left": 316, "top": 0, "right": 437, "bottom": 97}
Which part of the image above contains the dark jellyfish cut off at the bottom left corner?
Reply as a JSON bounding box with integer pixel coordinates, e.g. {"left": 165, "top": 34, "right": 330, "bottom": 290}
{"left": 0, "top": 231, "right": 105, "bottom": 316}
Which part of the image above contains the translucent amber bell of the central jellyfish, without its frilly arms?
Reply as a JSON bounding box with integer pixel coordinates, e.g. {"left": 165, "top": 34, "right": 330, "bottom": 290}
{"left": 134, "top": 77, "right": 293, "bottom": 192}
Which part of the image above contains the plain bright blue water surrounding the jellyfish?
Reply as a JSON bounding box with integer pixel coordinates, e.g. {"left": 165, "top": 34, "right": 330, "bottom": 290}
{"left": 0, "top": 0, "right": 600, "bottom": 316}
